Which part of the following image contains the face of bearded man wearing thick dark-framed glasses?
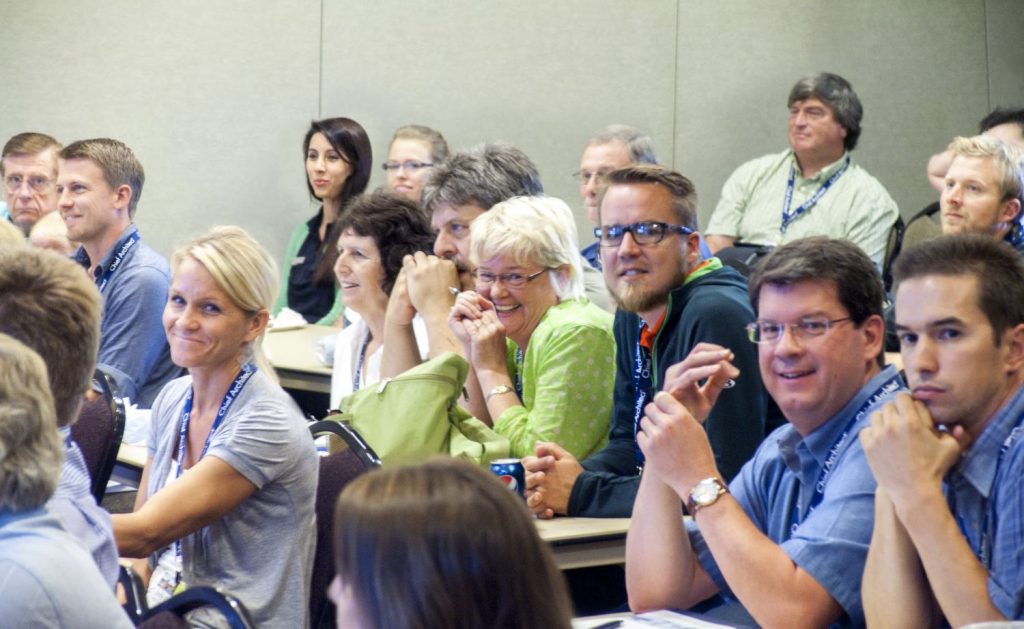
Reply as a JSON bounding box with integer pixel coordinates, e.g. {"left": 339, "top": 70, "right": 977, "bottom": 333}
{"left": 600, "top": 183, "right": 699, "bottom": 325}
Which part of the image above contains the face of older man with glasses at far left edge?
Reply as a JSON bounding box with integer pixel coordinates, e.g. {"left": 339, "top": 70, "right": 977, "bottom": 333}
{"left": 3, "top": 149, "right": 57, "bottom": 233}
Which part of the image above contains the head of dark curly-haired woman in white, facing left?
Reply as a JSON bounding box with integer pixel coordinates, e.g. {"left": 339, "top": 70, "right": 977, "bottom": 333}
{"left": 332, "top": 193, "right": 434, "bottom": 320}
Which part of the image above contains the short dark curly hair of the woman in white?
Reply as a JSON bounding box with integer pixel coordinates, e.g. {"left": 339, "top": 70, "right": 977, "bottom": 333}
{"left": 330, "top": 192, "right": 434, "bottom": 294}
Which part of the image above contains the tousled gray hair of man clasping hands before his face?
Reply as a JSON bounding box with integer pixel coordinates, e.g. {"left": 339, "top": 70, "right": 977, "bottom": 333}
{"left": 423, "top": 143, "right": 544, "bottom": 212}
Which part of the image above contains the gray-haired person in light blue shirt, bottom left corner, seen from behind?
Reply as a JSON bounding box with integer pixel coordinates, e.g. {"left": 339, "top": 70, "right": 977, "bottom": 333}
{"left": 0, "top": 334, "right": 130, "bottom": 627}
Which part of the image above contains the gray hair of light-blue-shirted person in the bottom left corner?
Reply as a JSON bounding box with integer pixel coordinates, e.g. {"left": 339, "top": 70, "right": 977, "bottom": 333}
{"left": 0, "top": 334, "right": 61, "bottom": 512}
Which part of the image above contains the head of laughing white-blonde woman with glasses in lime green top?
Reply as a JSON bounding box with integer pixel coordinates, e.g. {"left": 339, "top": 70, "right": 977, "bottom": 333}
{"left": 470, "top": 197, "right": 584, "bottom": 347}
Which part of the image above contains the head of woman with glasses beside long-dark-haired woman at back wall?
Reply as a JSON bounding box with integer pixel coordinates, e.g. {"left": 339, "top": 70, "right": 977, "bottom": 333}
{"left": 383, "top": 125, "right": 449, "bottom": 204}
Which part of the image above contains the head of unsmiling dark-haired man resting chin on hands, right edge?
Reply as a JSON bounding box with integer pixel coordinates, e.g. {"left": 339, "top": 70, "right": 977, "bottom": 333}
{"left": 894, "top": 236, "right": 1024, "bottom": 436}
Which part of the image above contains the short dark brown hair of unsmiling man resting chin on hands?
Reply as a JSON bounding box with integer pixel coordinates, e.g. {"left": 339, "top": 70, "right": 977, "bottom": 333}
{"left": 893, "top": 234, "right": 1024, "bottom": 344}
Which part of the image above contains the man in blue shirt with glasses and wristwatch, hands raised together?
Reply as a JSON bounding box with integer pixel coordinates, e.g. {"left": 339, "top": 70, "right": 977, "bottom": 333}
{"left": 626, "top": 237, "right": 902, "bottom": 627}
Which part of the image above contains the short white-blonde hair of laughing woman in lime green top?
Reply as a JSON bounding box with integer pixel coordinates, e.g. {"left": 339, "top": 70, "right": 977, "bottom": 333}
{"left": 470, "top": 197, "right": 585, "bottom": 299}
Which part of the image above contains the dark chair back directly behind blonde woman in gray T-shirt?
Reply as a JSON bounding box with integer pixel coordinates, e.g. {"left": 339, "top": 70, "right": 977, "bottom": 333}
{"left": 309, "top": 420, "right": 381, "bottom": 629}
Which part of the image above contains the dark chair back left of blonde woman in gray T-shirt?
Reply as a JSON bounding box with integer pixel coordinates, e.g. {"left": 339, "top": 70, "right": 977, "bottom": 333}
{"left": 71, "top": 369, "right": 125, "bottom": 504}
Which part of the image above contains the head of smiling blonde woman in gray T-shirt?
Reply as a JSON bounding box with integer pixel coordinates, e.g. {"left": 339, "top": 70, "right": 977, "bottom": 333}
{"left": 164, "top": 226, "right": 278, "bottom": 377}
